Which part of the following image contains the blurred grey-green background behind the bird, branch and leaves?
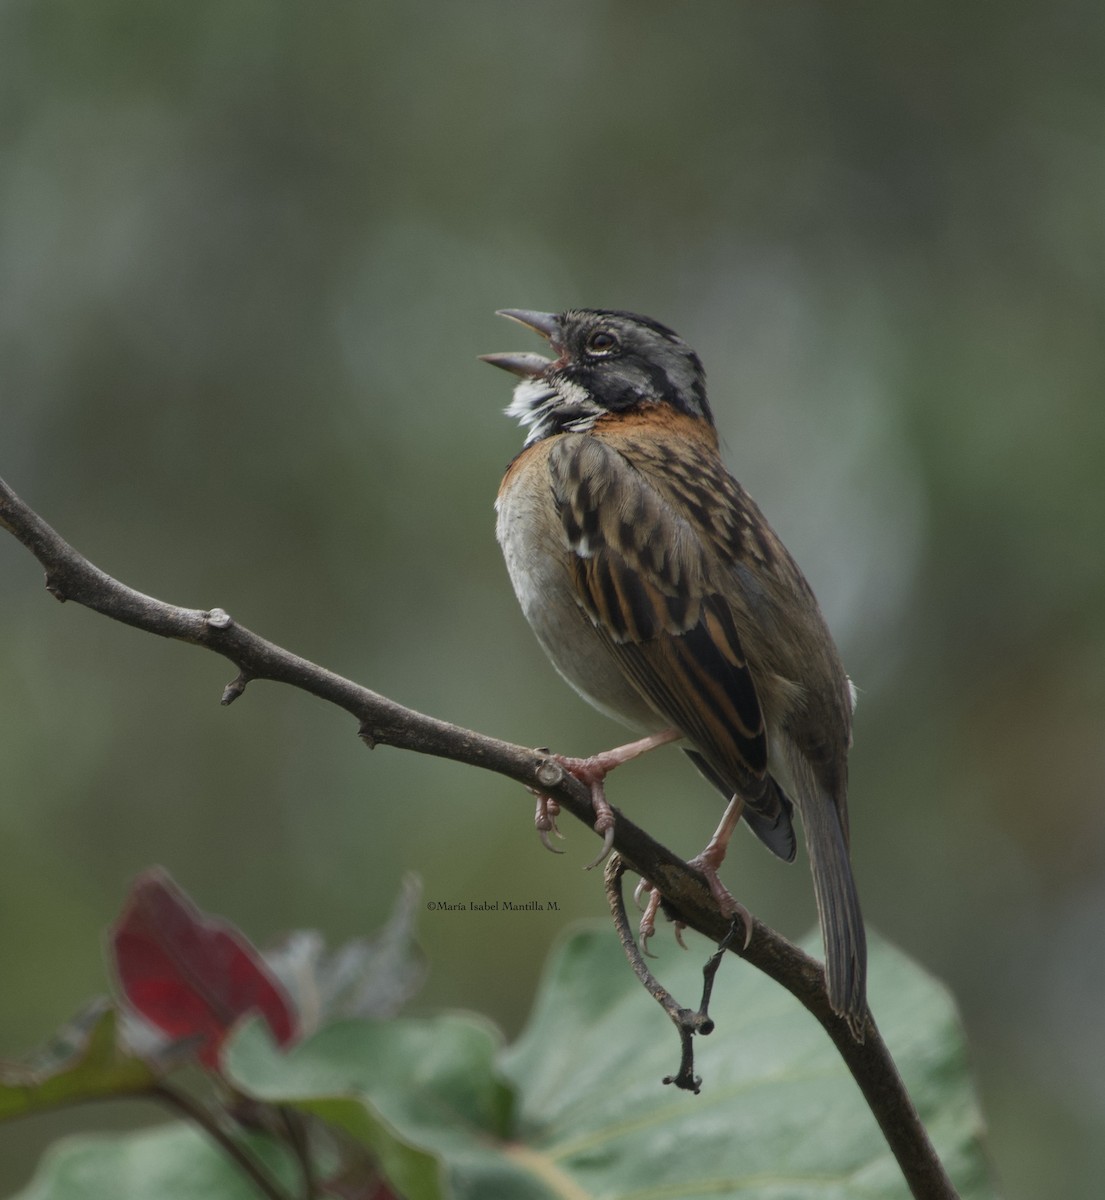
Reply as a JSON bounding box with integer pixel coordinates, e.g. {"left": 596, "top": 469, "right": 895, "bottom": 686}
{"left": 0, "top": 0, "right": 1105, "bottom": 1200}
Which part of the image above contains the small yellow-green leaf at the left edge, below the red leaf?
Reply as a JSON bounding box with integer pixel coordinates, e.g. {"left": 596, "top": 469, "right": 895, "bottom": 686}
{"left": 0, "top": 1000, "right": 155, "bottom": 1120}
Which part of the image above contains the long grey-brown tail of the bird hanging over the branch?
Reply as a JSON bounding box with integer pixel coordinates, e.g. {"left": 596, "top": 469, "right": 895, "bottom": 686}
{"left": 799, "top": 792, "right": 867, "bottom": 1042}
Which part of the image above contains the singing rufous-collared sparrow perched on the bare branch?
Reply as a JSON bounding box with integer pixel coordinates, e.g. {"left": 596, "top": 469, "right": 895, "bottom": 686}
{"left": 485, "top": 308, "right": 866, "bottom": 1037}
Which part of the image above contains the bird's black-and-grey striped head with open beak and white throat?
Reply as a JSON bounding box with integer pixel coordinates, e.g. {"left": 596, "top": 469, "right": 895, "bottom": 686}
{"left": 481, "top": 308, "right": 713, "bottom": 445}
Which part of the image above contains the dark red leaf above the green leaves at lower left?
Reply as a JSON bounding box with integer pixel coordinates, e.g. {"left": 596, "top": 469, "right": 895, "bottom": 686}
{"left": 110, "top": 866, "right": 296, "bottom": 1068}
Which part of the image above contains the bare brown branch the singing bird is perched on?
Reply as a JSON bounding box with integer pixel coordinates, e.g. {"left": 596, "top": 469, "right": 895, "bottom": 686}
{"left": 0, "top": 480, "right": 956, "bottom": 1200}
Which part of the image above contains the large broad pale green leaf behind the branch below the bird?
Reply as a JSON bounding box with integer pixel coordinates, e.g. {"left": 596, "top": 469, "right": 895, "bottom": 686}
{"left": 500, "top": 930, "right": 995, "bottom": 1200}
